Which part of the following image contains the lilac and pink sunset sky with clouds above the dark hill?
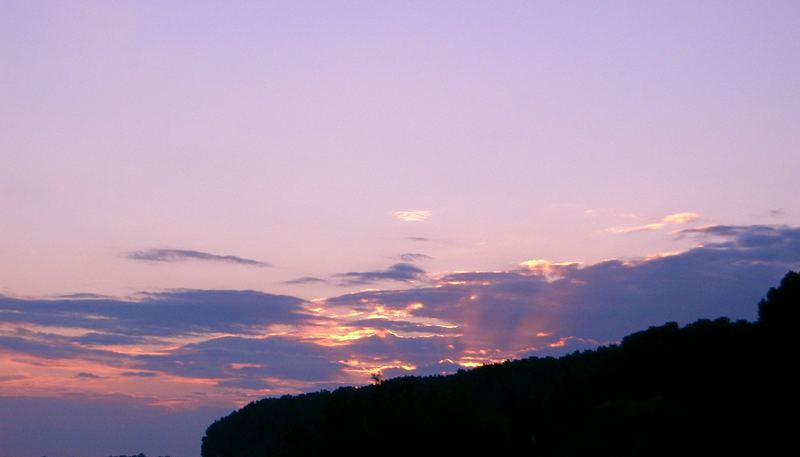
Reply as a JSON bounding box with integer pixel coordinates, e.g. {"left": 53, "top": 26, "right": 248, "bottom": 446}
{"left": 0, "top": 0, "right": 800, "bottom": 457}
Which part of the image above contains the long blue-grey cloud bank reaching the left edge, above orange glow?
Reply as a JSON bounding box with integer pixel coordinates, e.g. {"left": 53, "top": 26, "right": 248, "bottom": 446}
{"left": 0, "top": 290, "right": 306, "bottom": 336}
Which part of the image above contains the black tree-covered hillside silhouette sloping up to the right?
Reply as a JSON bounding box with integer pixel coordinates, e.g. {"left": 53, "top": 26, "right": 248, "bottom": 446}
{"left": 202, "top": 272, "right": 800, "bottom": 457}
